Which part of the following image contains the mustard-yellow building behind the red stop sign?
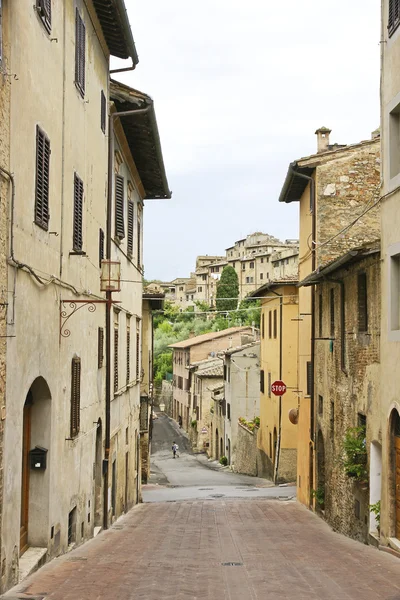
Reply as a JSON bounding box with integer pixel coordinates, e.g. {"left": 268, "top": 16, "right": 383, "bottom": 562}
{"left": 250, "top": 278, "right": 299, "bottom": 482}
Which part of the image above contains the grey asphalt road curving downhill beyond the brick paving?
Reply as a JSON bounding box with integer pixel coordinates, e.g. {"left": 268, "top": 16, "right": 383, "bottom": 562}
{"left": 143, "top": 413, "right": 296, "bottom": 502}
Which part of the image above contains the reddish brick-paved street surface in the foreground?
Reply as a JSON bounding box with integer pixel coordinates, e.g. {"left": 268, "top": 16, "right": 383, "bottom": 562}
{"left": 4, "top": 499, "right": 400, "bottom": 600}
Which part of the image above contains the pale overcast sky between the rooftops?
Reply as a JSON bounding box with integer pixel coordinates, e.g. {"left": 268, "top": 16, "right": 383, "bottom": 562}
{"left": 113, "top": 0, "right": 380, "bottom": 281}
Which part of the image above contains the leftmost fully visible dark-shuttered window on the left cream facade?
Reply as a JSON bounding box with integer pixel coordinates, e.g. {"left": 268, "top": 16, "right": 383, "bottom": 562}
{"left": 35, "top": 126, "right": 50, "bottom": 231}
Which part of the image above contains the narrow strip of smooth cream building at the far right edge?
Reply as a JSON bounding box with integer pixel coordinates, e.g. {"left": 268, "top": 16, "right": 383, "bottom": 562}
{"left": 380, "top": 0, "right": 400, "bottom": 550}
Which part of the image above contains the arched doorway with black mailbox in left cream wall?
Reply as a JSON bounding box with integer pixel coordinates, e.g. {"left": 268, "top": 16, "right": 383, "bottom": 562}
{"left": 20, "top": 377, "right": 51, "bottom": 554}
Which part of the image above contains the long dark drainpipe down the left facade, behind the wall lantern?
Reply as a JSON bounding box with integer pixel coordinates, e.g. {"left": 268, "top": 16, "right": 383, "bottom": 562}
{"left": 103, "top": 104, "right": 152, "bottom": 529}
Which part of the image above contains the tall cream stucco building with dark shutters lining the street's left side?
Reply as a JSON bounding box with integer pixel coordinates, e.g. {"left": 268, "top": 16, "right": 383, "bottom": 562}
{"left": 1, "top": 0, "right": 170, "bottom": 590}
